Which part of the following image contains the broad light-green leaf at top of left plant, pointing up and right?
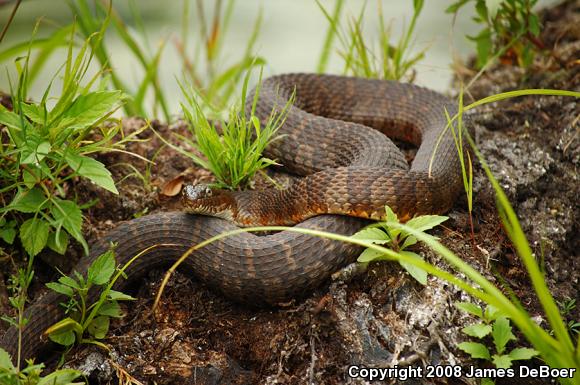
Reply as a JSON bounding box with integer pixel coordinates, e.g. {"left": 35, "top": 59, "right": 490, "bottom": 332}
{"left": 58, "top": 91, "right": 124, "bottom": 129}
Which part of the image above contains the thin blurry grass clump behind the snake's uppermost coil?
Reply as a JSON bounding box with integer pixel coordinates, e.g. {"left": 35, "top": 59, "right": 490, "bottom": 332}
{"left": 317, "top": 0, "right": 425, "bottom": 81}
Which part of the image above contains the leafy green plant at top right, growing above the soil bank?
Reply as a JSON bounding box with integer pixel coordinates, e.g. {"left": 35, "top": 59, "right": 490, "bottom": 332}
{"left": 446, "top": 0, "right": 544, "bottom": 68}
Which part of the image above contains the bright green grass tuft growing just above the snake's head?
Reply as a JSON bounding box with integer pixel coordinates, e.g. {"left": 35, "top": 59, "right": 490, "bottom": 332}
{"left": 178, "top": 71, "right": 294, "bottom": 190}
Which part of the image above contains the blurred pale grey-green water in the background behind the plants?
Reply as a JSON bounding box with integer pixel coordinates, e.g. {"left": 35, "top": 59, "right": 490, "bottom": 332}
{"left": 0, "top": 0, "right": 554, "bottom": 113}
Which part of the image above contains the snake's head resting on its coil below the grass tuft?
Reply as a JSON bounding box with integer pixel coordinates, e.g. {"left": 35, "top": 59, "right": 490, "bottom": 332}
{"left": 182, "top": 184, "right": 237, "bottom": 220}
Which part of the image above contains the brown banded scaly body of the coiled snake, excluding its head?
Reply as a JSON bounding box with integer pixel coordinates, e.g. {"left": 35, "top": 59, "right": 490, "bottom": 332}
{"left": 0, "top": 74, "right": 461, "bottom": 358}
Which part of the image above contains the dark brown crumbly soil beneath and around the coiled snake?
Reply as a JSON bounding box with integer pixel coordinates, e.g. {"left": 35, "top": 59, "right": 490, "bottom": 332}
{"left": 0, "top": 1, "right": 580, "bottom": 384}
